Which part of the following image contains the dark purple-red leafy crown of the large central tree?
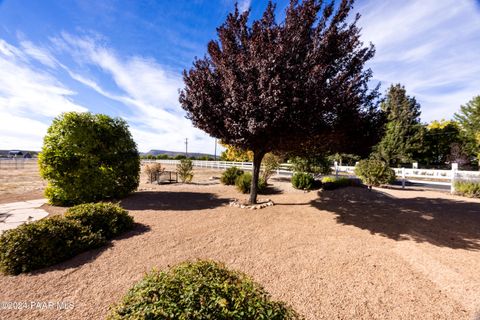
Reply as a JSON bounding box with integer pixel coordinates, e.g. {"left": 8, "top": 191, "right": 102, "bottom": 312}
{"left": 180, "top": 0, "right": 377, "bottom": 201}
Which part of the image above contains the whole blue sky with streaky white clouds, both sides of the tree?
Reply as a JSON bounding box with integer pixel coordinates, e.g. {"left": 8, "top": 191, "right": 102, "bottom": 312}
{"left": 0, "top": 0, "right": 480, "bottom": 153}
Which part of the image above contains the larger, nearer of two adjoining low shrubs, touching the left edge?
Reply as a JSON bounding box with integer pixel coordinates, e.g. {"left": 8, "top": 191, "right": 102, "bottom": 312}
{"left": 0, "top": 216, "right": 105, "bottom": 275}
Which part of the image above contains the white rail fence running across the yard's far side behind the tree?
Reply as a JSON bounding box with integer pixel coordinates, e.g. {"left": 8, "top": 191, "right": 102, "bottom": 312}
{"left": 146, "top": 160, "right": 480, "bottom": 192}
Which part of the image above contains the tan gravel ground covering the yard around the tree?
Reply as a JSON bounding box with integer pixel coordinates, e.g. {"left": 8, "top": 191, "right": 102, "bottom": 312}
{"left": 0, "top": 169, "right": 480, "bottom": 320}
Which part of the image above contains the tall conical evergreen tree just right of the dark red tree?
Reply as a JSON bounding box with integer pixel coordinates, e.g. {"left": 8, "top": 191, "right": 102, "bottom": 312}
{"left": 373, "top": 84, "right": 422, "bottom": 166}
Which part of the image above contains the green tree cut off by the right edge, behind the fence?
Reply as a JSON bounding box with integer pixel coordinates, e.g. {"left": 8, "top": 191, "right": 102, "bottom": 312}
{"left": 454, "top": 96, "right": 480, "bottom": 165}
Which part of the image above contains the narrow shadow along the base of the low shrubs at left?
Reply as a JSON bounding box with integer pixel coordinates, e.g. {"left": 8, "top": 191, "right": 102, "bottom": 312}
{"left": 31, "top": 223, "right": 150, "bottom": 275}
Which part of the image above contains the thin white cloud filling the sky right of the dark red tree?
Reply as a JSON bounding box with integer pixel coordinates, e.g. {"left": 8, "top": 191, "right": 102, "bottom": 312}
{"left": 357, "top": 0, "right": 480, "bottom": 121}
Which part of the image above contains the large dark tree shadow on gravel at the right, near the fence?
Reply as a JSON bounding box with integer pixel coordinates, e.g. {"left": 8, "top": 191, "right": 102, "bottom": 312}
{"left": 311, "top": 187, "right": 480, "bottom": 250}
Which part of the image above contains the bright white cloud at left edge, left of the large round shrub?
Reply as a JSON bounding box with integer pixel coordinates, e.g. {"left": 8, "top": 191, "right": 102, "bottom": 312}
{"left": 0, "top": 39, "right": 87, "bottom": 150}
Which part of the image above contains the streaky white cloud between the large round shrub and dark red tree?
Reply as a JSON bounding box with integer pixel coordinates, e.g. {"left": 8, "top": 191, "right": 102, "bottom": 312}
{"left": 53, "top": 34, "right": 214, "bottom": 153}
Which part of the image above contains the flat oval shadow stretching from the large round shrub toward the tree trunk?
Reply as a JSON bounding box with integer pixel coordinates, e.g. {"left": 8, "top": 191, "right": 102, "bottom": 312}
{"left": 121, "top": 191, "right": 229, "bottom": 211}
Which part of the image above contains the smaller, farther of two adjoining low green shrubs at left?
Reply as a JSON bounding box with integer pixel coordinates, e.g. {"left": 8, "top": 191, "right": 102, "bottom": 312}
{"left": 65, "top": 202, "right": 134, "bottom": 239}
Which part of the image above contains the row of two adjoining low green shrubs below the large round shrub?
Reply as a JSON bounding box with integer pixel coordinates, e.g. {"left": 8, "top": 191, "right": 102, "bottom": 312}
{"left": 0, "top": 203, "right": 133, "bottom": 275}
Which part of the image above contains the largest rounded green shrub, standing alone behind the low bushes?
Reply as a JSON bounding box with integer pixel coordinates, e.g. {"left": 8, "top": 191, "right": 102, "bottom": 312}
{"left": 39, "top": 112, "right": 140, "bottom": 205}
